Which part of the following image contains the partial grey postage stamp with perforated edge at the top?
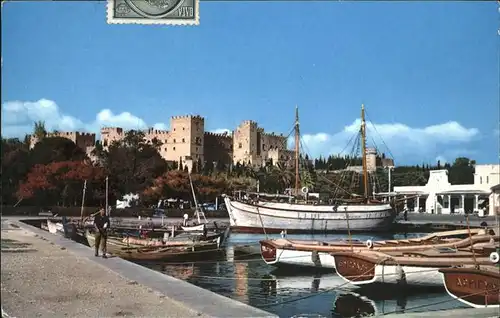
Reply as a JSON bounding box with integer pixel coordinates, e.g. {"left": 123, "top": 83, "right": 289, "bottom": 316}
{"left": 107, "top": 0, "right": 200, "bottom": 25}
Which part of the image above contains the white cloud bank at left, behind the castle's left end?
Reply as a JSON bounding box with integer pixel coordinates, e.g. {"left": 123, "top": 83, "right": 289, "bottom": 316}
{"left": 2, "top": 99, "right": 167, "bottom": 137}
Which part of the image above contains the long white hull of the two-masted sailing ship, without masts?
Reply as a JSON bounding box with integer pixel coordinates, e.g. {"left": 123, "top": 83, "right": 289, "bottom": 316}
{"left": 224, "top": 196, "right": 395, "bottom": 234}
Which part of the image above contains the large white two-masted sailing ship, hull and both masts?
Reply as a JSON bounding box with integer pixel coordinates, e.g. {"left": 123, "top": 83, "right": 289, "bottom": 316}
{"left": 223, "top": 106, "right": 396, "bottom": 233}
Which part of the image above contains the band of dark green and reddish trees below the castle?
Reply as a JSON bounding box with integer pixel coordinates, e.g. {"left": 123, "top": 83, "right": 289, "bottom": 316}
{"left": 1, "top": 122, "right": 475, "bottom": 206}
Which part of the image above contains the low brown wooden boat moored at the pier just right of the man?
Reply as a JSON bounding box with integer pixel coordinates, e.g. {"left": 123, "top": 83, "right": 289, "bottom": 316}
{"left": 86, "top": 230, "right": 222, "bottom": 262}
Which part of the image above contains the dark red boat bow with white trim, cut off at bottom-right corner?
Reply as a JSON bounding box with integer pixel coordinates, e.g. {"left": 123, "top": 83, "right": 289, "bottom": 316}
{"left": 439, "top": 258, "right": 500, "bottom": 308}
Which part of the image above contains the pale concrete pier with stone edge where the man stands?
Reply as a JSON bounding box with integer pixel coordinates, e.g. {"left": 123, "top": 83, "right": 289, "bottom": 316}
{"left": 1, "top": 219, "right": 277, "bottom": 318}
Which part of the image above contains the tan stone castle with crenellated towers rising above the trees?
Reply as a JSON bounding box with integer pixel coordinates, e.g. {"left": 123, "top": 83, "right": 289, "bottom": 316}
{"left": 30, "top": 115, "right": 295, "bottom": 170}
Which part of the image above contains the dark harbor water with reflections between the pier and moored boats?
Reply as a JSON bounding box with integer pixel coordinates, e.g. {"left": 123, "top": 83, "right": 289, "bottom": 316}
{"left": 143, "top": 233, "right": 466, "bottom": 317}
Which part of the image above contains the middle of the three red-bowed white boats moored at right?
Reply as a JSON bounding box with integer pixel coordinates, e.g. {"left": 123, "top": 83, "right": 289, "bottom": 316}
{"left": 332, "top": 241, "right": 499, "bottom": 287}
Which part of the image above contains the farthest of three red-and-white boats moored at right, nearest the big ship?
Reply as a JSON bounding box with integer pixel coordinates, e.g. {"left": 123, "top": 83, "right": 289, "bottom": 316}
{"left": 260, "top": 229, "right": 494, "bottom": 268}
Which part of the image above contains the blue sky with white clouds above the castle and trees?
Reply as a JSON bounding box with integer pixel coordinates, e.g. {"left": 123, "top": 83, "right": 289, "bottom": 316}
{"left": 1, "top": 1, "right": 500, "bottom": 165}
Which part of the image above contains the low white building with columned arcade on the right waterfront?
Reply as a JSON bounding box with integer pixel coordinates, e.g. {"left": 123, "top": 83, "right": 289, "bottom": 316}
{"left": 394, "top": 165, "right": 500, "bottom": 215}
